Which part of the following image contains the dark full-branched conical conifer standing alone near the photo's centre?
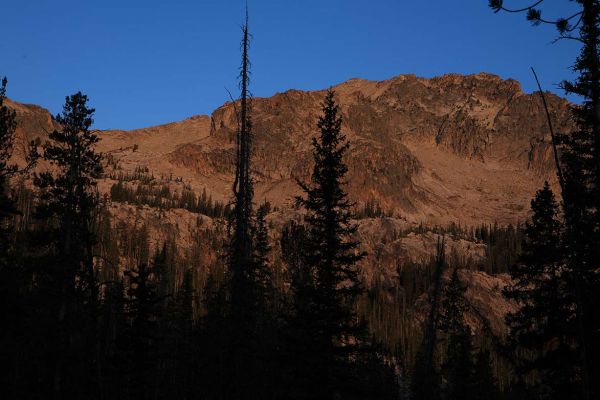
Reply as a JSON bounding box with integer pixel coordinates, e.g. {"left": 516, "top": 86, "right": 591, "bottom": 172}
{"left": 293, "top": 90, "right": 364, "bottom": 398}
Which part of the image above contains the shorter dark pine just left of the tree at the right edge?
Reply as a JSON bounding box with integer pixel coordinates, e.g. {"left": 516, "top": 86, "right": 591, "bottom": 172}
{"left": 504, "top": 182, "right": 581, "bottom": 399}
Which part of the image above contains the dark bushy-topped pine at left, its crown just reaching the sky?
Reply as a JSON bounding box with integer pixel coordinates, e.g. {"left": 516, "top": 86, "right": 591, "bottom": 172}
{"left": 34, "top": 93, "right": 102, "bottom": 397}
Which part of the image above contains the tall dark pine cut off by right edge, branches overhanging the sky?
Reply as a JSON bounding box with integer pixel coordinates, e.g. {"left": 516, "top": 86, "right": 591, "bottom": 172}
{"left": 489, "top": 0, "right": 600, "bottom": 400}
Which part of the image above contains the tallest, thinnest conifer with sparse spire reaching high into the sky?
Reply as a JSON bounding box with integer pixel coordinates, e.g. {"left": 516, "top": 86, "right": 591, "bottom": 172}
{"left": 222, "top": 10, "right": 268, "bottom": 399}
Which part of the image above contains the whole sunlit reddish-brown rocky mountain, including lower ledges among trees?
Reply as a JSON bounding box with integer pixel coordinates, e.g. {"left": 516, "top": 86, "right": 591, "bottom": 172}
{"left": 8, "top": 73, "right": 573, "bottom": 338}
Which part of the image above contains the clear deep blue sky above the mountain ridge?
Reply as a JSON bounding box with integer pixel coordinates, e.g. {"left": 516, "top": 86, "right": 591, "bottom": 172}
{"left": 0, "top": 0, "right": 578, "bottom": 129}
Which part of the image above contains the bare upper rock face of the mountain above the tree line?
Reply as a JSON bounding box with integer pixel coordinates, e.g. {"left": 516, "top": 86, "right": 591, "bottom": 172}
{"left": 92, "top": 74, "right": 570, "bottom": 225}
